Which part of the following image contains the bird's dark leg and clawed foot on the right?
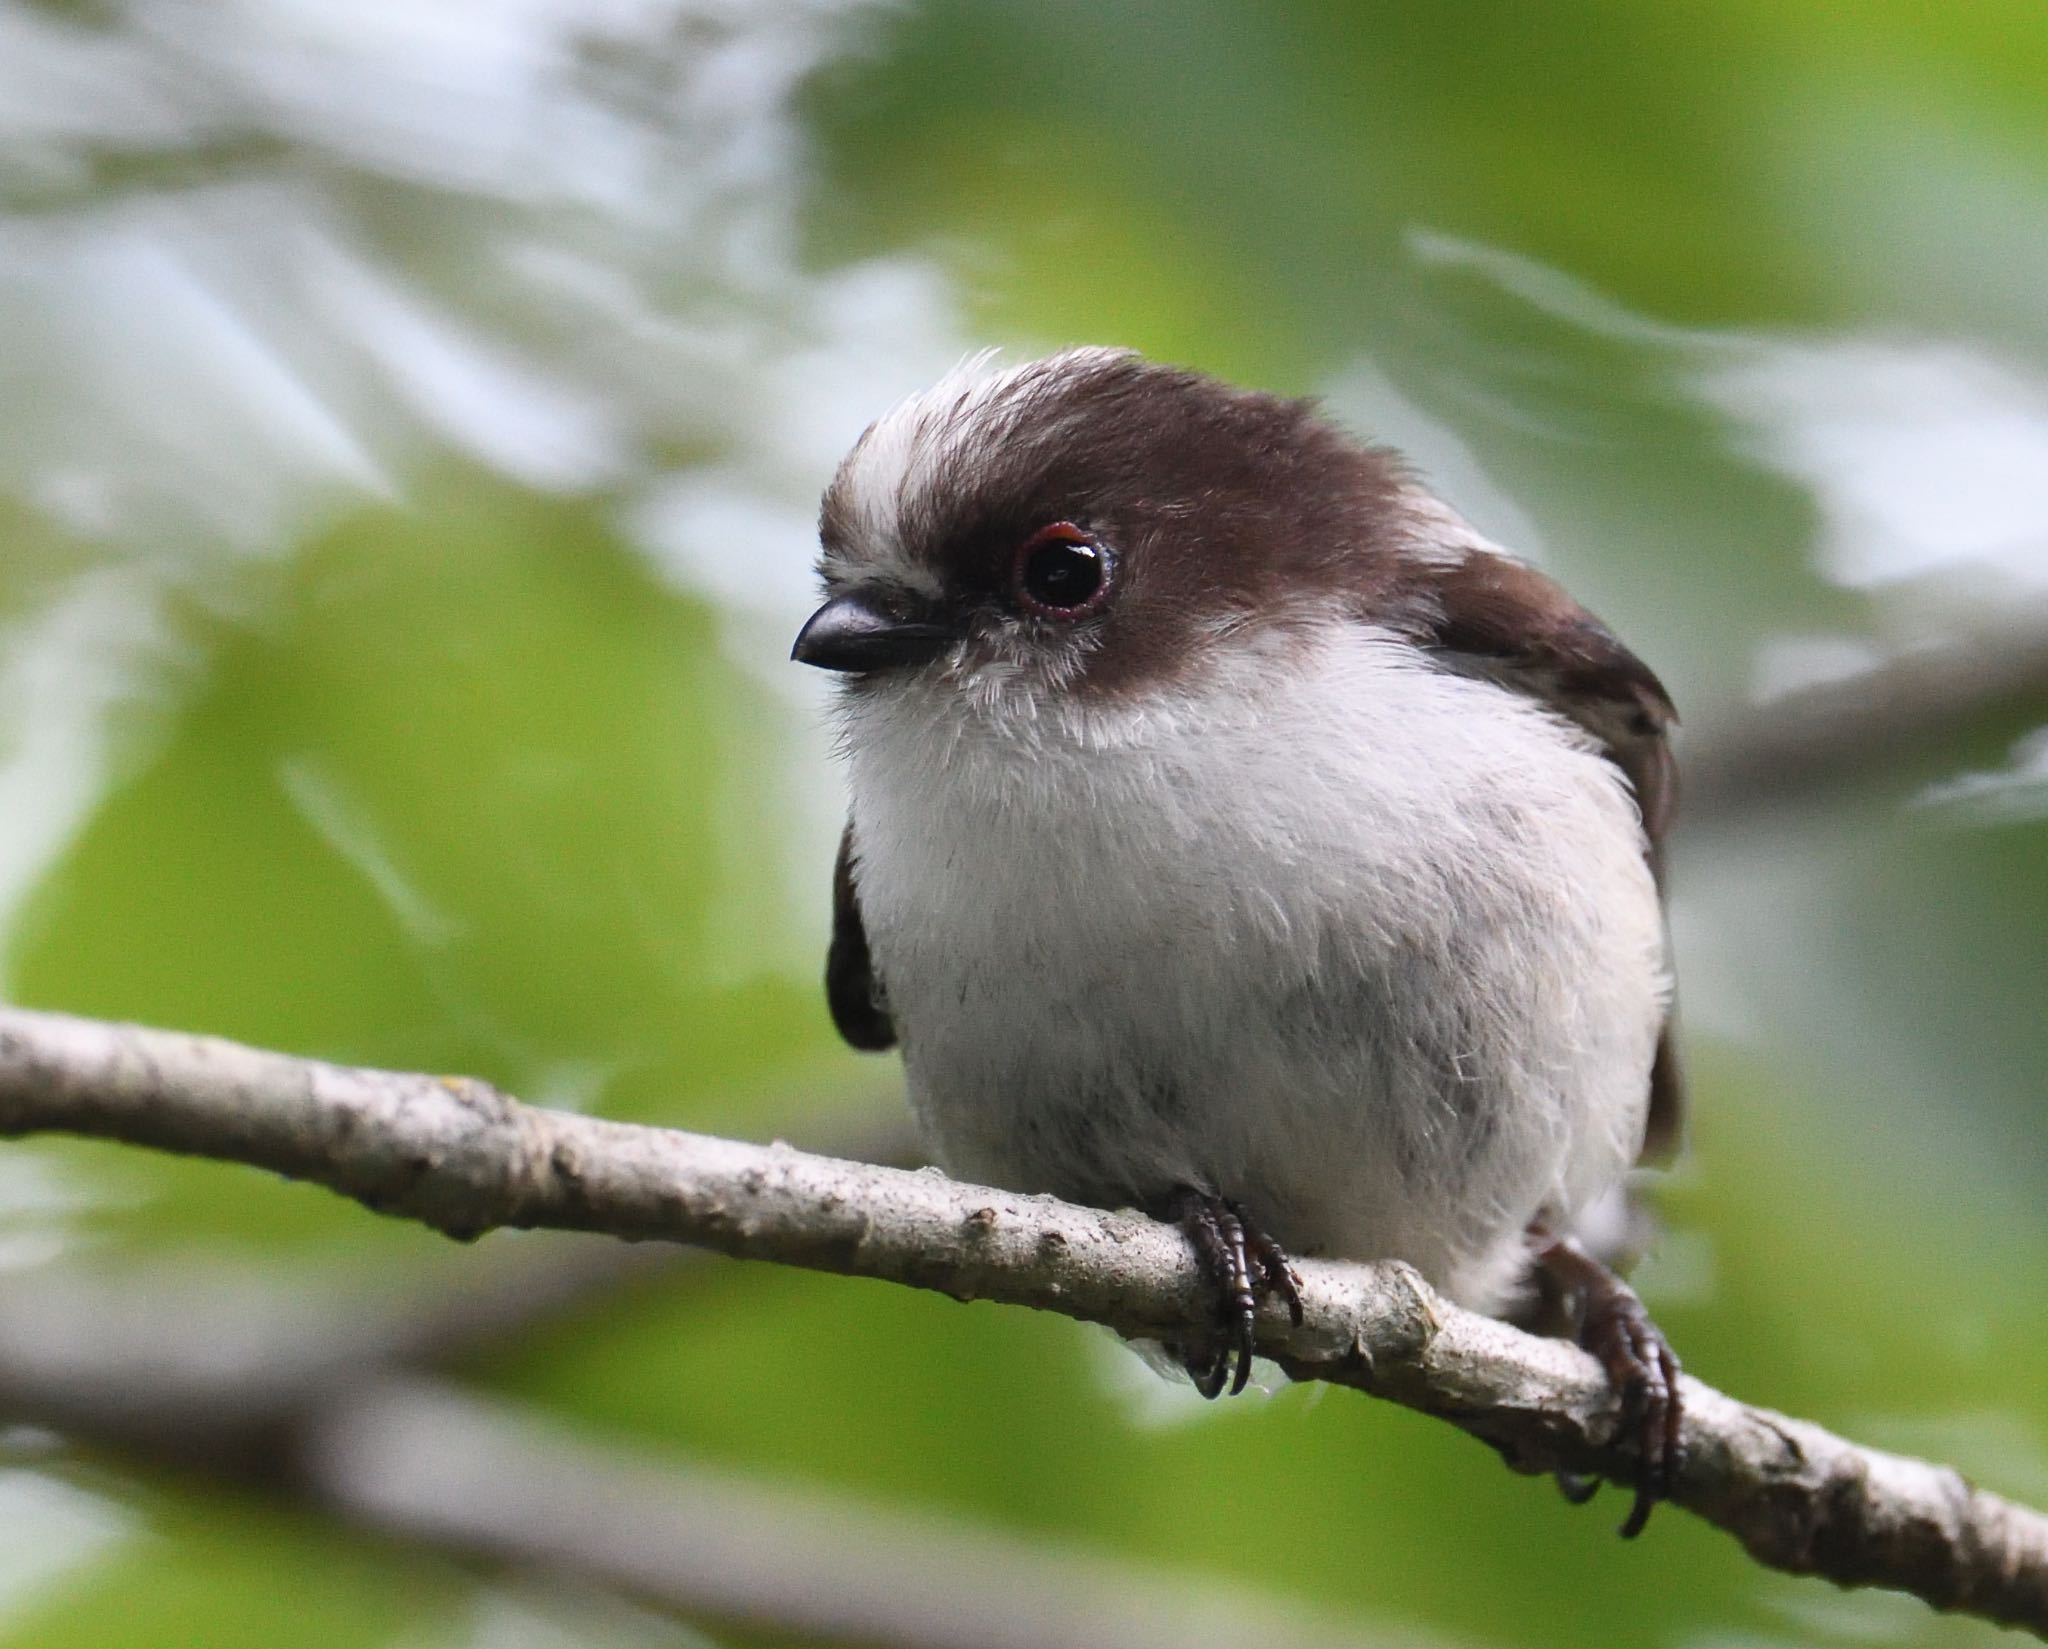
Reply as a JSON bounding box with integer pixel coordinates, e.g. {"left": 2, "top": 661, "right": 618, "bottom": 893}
{"left": 1530, "top": 1227, "right": 1683, "bottom": 1540}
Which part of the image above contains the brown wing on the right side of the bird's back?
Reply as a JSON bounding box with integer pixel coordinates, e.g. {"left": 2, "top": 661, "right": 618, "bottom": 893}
{"left": 1425, "top": 549, "right": 1686, "bottom": 1161}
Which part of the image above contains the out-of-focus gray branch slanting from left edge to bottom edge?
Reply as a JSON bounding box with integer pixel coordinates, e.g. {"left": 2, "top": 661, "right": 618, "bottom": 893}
{"left": 0, "top": 1256, "right": 1391, "bottom": 1649}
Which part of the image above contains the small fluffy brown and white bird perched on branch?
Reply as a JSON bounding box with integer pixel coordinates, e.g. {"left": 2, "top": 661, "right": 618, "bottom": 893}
{"left": 793, "top": 346, "right": 1683, "bottom": 1534}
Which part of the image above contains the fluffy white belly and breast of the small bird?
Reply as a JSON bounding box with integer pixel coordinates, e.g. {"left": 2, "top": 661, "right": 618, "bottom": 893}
{"left": 846, "top": 629, "right": 1665, "bottom": 1309}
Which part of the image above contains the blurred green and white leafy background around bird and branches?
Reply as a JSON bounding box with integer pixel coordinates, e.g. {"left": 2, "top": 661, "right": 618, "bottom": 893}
{"left": 0, "top": 0, "right": 2048, "bottom": 1649}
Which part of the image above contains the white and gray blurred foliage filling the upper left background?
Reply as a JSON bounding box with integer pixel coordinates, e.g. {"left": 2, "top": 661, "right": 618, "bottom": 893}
{"left": 0, "top": 0, "right": 958, "bottom": 987}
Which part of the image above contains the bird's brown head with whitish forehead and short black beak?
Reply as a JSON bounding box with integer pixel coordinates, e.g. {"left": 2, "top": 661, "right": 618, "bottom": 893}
{"left": 795, "top": 348, "right": 1442, "bottom": 711}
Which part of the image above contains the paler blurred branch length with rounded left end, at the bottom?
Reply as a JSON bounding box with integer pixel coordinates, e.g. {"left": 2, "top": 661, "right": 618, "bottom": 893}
{"left": 307, "top": 1381, "right": 1417, "bottom": 1649}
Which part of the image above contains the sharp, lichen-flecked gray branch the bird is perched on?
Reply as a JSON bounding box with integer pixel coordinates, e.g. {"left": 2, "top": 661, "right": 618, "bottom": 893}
{"left": 0, "top": 1010, "right": 2048, "bottom": 1637}
